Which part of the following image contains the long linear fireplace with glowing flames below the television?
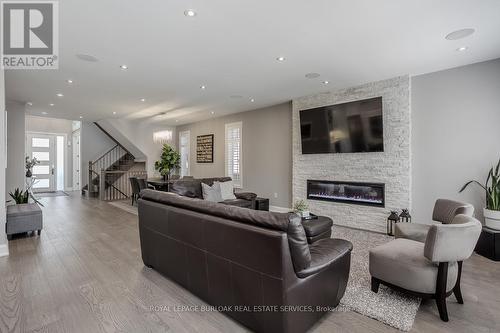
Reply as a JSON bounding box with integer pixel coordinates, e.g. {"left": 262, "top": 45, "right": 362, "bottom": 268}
{"left": 307, "top": 180, "right": 385, "bottom": 207}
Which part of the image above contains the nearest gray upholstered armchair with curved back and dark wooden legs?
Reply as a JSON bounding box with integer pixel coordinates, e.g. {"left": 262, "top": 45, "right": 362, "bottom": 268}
{"left": 370, "top": 214, "right": 482, "bottom": 321}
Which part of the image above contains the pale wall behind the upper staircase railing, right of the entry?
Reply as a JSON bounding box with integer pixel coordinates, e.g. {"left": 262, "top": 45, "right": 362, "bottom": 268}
{"left": 80, "top": 122, "right": 115, "bottom": 188}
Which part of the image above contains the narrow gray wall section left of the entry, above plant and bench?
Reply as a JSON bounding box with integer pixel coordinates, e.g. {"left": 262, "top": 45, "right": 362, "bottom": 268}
{"left": 5, "top": 102, "right": 26, "bottom": 195}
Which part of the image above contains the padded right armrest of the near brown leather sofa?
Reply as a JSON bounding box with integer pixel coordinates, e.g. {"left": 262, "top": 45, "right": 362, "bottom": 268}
{"left": 297, "top": 238, "right": 352, "bottom": 278}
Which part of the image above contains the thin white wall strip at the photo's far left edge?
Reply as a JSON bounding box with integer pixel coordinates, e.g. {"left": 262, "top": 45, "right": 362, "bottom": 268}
{"left": 0, "top": 69, "right": 9, "bottom": 257}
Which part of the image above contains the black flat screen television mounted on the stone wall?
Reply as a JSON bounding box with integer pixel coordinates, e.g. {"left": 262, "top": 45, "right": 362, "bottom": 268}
{"left": 300, "top": 97, "right": 384, "bottom": 154}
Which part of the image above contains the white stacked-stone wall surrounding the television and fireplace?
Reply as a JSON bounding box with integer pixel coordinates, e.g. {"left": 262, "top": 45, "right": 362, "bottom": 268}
{"left": 292, "top": 76, "right": 411, "bottom": 232}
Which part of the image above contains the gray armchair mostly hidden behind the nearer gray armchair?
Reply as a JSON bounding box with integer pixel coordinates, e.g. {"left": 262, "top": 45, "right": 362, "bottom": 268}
{"left": 394, "top": 199, "right": 474, "bottom": 243}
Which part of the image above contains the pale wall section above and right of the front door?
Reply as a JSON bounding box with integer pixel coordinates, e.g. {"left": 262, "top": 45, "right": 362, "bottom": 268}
{"left": 26, "top": 116, "right": 73, "bottom": 189}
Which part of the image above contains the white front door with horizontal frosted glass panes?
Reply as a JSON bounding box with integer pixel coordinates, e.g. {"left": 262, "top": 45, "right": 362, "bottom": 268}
{"left": 26, "top": 133, "right": 56, "bottom": 192}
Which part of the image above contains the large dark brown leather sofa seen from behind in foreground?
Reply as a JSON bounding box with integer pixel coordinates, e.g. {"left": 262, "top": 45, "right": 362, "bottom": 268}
{"left": 139, "top": 190, "right": 352, "bottom": 333}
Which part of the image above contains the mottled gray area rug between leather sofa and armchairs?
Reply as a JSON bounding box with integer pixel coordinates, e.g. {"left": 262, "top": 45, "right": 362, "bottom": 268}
{"left": 332, "top": 225, "right": 420, "bottom": 331}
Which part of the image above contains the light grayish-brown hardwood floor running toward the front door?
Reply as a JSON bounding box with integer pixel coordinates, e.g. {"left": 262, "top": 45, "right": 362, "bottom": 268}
{"left": 0, "top": 193, "right": 500, "bottom": 333}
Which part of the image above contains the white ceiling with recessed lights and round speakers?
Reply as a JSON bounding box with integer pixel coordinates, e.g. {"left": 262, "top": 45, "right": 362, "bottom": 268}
{"left": 6, "top": 0, "right": 500, "bottom": 125}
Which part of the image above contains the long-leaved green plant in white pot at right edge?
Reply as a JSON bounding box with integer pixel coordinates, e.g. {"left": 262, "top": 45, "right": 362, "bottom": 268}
{"left": 459, "top": 159, "right": 500, "bottom": 230}
